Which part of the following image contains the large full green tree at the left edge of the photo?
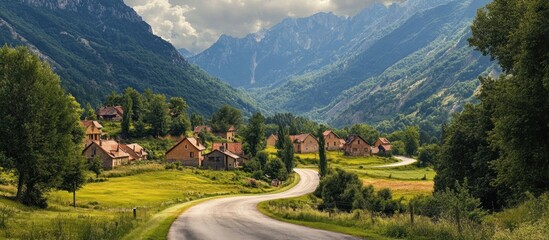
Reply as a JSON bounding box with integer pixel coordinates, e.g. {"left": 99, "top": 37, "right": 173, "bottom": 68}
{"left": 0, "top": 46, "right": 84, "bottom": 207}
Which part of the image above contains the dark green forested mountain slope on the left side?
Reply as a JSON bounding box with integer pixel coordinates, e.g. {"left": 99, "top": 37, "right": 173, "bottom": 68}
{"left": 0, "top": 0, "right": 255, "bottom": 114}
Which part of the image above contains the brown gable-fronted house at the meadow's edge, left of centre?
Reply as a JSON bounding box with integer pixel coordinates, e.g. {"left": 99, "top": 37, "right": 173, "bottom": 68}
{"left": 166, "top": 137, "right": 206, "bottom": 167}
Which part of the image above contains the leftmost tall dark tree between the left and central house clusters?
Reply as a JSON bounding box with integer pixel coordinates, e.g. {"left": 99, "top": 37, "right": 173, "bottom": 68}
{"left": 244, "top": 112, "right": 265, "bottom": 157}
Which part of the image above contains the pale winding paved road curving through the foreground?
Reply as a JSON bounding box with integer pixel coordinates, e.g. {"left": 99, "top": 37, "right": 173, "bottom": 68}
{"left": 168, "top": 169, "right": 357, "bottom": 240}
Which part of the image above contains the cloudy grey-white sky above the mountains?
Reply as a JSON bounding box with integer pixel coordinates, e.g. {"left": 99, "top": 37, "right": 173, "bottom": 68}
{"left": 124, "top": 0, "right": 398, "bottom": 53}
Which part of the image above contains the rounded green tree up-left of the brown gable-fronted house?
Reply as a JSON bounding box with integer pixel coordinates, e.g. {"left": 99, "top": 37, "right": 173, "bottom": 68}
{"left": 147, "top": 94, "right": 170, "bottom": 138}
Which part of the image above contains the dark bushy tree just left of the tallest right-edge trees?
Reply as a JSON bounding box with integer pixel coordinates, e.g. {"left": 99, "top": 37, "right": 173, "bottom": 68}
{"left": 432, "top": 105, "right": 500, "bottom": 208}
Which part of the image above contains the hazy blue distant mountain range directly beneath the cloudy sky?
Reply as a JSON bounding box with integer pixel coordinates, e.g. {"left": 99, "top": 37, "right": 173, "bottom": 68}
{"left": 189, "top": 0, "right": 456, "bottom": 88}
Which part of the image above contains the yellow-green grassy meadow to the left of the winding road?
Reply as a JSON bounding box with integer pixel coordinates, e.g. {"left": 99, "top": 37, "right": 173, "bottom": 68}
{"left": 0, "top": 166, "right": 288, "bottom": 239}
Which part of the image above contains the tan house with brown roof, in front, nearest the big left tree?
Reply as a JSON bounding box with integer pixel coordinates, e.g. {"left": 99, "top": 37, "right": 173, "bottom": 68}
{"left": 82, "top": 140, "right": 130, "bottom": 169}
